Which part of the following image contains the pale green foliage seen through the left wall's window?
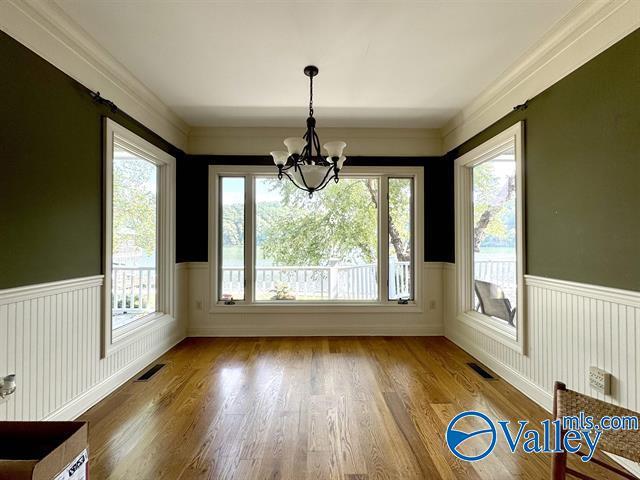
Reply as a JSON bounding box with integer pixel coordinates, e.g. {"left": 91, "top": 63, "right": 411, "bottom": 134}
{"left": 113, "top": 159, "right": 157, "bottom": 255}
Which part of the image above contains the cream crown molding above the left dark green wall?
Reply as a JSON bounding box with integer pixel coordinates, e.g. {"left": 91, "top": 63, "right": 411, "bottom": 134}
{"left": 0, "top": 0, "right": 189, "bottom": 149}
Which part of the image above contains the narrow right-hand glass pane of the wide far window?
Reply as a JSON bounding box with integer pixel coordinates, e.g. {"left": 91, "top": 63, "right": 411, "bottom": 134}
{"left": 389, "top": 178, "right": 413, "bottom": 300}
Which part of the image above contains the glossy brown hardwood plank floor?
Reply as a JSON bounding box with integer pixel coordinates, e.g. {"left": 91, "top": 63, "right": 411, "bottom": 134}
{"left": 81, "top": 337, "right": 632, "bottom": 480}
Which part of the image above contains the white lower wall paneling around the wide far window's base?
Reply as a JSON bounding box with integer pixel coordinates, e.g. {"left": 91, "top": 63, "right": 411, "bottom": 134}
{"left": 180, "top": 262, "right": 443, "bottom": 336}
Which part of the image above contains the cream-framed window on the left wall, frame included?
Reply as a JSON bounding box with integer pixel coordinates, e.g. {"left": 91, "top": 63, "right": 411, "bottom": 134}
{"left": 103, "top": 120, "right": 175, "bottom": 355}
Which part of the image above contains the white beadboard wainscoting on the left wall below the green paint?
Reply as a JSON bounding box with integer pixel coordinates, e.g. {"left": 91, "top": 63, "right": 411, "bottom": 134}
{"left": 0, "top": 275, "right": 185, "bottom": 420}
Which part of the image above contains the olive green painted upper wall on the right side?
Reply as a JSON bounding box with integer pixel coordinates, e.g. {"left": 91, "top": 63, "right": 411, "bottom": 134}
{"left": 448, "top": 30, "right": 640, "bottom": 291}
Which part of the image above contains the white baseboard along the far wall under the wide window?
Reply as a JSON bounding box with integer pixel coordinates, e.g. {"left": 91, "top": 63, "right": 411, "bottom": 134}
{"left": 187, "top": 324, "right": 444, "bottom": 337}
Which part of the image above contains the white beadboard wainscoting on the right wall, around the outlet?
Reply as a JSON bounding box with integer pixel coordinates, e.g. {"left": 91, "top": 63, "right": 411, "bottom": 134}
{"left": 443, "top": 264, "right": 640, "bottom": 474}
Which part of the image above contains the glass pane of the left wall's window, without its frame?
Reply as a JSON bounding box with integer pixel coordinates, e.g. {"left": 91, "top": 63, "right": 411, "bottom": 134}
{"left": 111, "top": 146, "right": 158, "bottom": 329}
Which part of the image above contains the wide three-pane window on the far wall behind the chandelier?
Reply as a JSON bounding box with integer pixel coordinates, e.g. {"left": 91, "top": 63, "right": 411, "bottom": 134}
{"left": 211, "top": 166, "right": 422, "bottom": 309}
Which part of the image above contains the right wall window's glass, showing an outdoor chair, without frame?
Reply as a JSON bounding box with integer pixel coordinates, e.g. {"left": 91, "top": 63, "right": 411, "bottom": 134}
{"left": 472, "top": 149, "right": 518, "bottom": 325}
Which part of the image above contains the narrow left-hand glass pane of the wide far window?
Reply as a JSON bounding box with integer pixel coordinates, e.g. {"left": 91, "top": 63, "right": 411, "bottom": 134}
{"left": 220, "top": 177, "right": 244, "bottom": 301}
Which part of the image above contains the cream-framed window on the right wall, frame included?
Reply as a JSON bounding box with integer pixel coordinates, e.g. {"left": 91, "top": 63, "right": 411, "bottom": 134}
{"left": 455, "top": 123, "right": 525, "bottom": 351}
